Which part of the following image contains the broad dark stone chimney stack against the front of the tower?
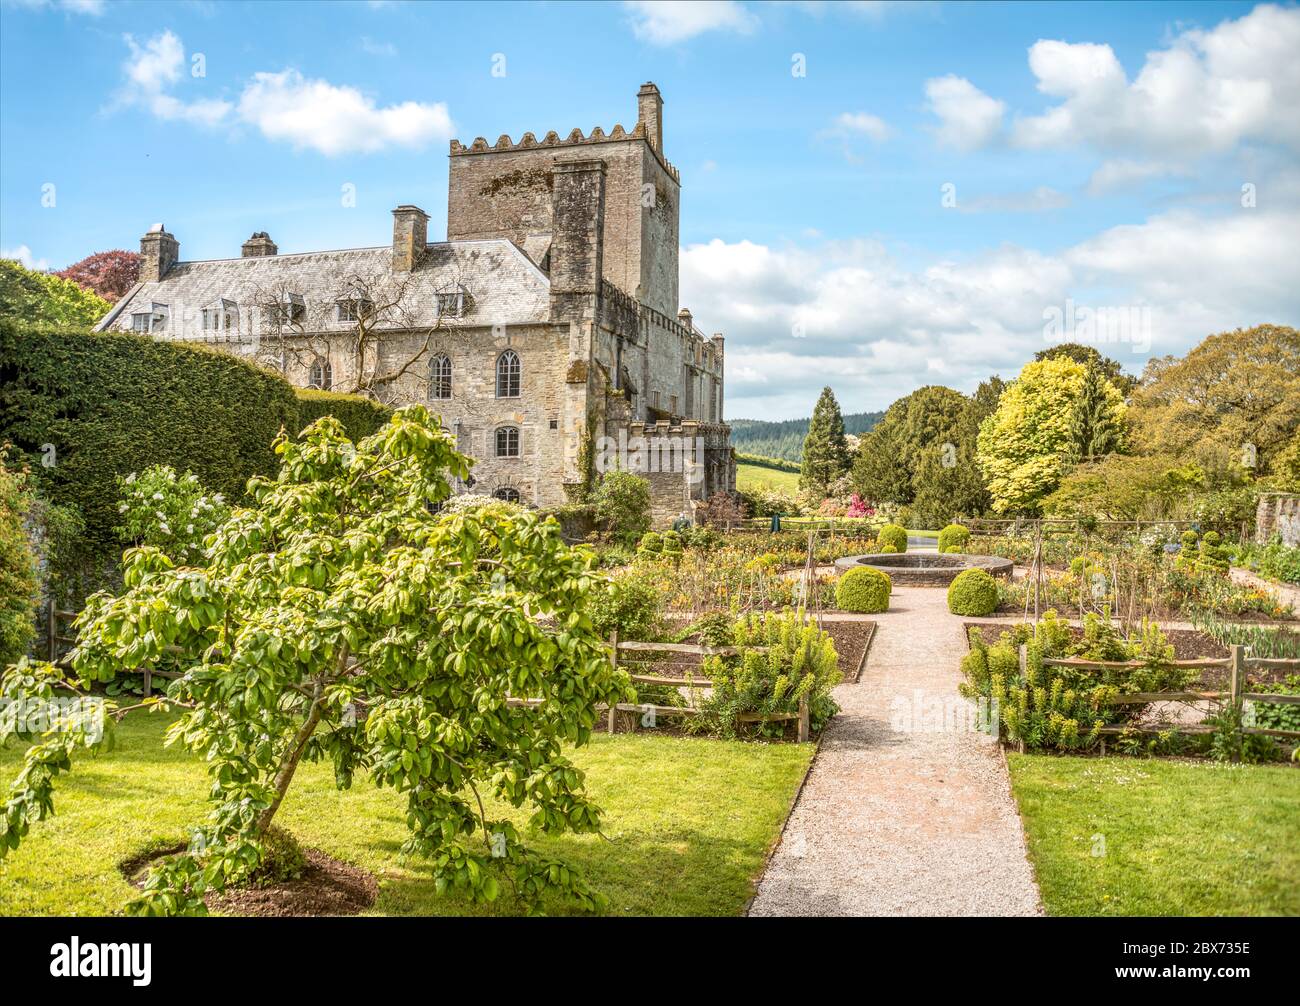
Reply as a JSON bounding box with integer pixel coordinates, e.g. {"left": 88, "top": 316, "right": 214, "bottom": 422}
{"left": 551, "top": 160, "right": 605, "bottom": 321}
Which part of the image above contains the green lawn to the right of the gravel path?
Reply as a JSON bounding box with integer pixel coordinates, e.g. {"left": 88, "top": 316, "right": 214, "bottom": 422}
{"left": 1008, "top": 754, "right": 1300, "bottom": 915}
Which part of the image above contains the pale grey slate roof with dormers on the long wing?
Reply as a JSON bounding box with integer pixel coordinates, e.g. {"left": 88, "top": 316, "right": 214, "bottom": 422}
{"left": 96, "top": 238, "right": 550, "bottom": 339}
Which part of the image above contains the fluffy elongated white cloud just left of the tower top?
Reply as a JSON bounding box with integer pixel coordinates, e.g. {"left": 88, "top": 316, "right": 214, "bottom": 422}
{"left": 239, "top": 70, "right": 451, "bottom": 156}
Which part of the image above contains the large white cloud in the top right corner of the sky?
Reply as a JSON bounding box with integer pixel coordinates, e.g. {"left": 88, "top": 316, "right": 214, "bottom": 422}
{"left": 1013, "top": 4, "right": 1300, "bottom": 157}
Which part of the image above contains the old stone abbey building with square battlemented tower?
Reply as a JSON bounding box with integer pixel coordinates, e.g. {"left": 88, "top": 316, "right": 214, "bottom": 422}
{"left": 99, "top": 83, "right": 736, "bottom": 524}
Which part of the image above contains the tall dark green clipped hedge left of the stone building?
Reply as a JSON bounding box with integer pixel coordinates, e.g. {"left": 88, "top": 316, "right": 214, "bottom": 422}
{"left": 0, "top": 321, "right": 386, "bottom": 551}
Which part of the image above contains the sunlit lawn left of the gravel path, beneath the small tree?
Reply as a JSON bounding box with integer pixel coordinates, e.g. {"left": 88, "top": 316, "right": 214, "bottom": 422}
{"left": 0, "top": 714, "right": 813, "bottom": 915}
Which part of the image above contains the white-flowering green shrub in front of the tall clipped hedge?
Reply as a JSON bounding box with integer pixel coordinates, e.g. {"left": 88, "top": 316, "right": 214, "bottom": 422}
{"left": 116, "top": 464, "right": 230, "bottom": 564}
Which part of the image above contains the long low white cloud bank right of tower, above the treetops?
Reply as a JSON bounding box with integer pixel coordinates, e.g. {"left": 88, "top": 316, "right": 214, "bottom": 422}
{"left": 681, "top": 209, "right": 1300, "bottom": 417}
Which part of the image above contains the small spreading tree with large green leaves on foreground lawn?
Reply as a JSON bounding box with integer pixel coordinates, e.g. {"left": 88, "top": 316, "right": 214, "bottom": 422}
{"left": 0, "top": 406, "right": 631, "bottom": 914}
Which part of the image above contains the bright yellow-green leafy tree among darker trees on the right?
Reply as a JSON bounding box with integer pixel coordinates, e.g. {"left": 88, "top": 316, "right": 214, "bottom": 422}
{"left": 976, "top": 356, "right": 1125, "bottom": 513}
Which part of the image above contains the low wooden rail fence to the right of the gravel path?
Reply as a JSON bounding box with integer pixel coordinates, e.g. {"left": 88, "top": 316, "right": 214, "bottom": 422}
{"left": 1021, "top": 643, "right": 1300, "bottom": 754}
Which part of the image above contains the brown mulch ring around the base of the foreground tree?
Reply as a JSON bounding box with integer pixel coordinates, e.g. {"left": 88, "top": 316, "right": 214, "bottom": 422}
{"left": 118, "top": 844, "right": 380, "bottom": 918}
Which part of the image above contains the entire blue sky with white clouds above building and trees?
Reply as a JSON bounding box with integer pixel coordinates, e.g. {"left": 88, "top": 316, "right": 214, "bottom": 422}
{"left": 0, "top": 0, "right": 1300, "bottom": 419}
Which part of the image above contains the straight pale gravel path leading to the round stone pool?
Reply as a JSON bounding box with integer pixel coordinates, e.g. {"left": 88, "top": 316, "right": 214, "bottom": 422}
{"left": 750, "top": 587, "right": 1041, "bottom": 915}
